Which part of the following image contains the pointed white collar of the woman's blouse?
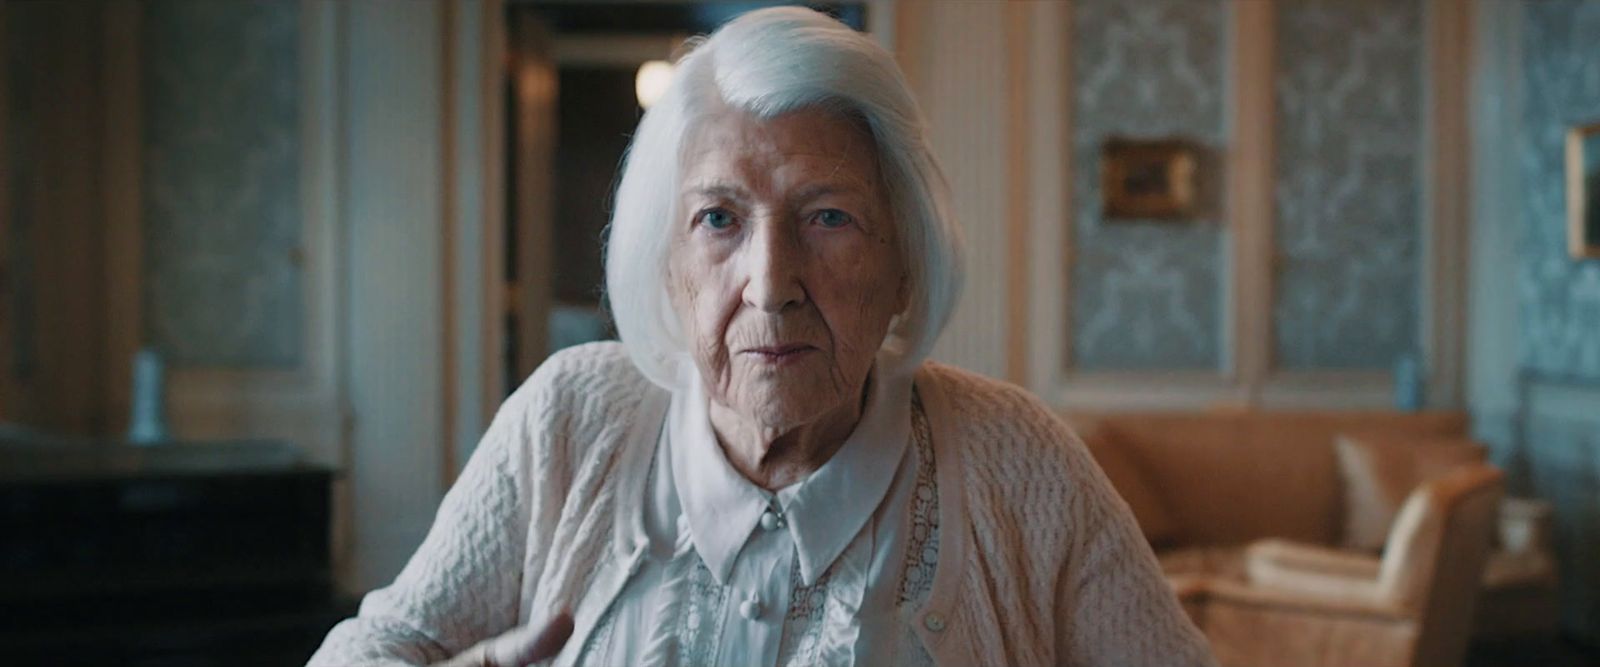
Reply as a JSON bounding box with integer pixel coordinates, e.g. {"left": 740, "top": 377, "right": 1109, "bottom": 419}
{"left": 667, "top": 361, "right": 912, "bottom": 585}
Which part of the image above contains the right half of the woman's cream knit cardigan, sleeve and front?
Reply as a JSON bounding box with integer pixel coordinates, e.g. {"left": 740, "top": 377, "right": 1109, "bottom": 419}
{"left": 930, "top": 363, "right": 1214, "bottom": 667}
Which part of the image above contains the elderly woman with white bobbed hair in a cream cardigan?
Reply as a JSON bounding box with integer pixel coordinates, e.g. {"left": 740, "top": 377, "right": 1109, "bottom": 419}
{"left": 312, "top": 8, "right": 1211, "bottom": 667}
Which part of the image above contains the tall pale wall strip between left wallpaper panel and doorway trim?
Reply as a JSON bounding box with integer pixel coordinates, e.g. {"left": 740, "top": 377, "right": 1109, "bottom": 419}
{"left": 338, "top": 0, "right": 450, "bottom": 590}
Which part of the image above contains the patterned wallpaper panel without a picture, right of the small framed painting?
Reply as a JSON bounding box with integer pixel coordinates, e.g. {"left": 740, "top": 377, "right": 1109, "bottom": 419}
{"left": 1272, "top": 0, "right": 1424, "bottom": 369}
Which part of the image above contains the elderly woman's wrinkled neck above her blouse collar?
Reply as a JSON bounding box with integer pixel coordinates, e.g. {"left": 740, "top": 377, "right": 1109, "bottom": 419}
{"left": 710, "top": 374, "right": 872, "bottom": 491}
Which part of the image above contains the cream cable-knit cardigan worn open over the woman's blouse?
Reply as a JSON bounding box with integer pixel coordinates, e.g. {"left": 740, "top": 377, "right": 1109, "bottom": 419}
{"left": 310, "top": 342, "right": 1214, "bottom": 667}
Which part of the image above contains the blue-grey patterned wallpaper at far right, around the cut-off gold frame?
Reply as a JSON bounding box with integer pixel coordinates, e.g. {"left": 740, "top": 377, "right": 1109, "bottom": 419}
{"left": 1510, "top": 0, "right": 1600, "bottom": 641}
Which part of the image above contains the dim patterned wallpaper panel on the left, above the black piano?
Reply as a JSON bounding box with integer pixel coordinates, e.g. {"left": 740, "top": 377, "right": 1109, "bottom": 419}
{"left": 141, "top": 0, "right": 304, "bottom": 368}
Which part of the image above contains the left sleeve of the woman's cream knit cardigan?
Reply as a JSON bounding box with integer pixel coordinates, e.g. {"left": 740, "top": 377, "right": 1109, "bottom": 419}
{"left": 310, "top": 364, "right": 549, "bottom": 667}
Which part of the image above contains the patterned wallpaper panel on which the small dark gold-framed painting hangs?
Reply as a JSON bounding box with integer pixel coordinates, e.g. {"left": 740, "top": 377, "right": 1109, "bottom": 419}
{"left": 1070, "top": 0, "right": 1227, "bottom": 369}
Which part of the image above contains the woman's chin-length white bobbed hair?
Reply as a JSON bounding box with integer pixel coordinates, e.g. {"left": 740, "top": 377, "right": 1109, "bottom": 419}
{"left": 605, "top": 6, "right": 963, "bottom": 389}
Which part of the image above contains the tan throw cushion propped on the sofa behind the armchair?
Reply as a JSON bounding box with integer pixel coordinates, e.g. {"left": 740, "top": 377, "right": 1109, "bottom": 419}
{"left": 1334, "top": 433, "right": 1485, "bottom": 552}
